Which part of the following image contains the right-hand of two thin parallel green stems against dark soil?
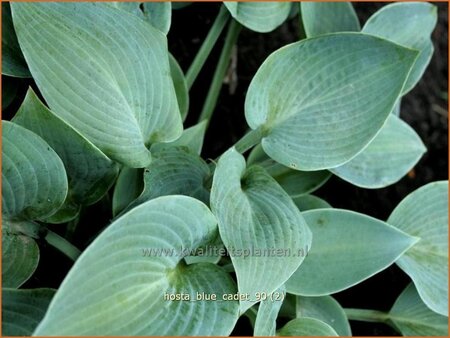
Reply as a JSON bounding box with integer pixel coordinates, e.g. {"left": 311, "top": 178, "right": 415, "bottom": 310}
{"left": 198, "top": 20, "right": 242, "bottom": 123}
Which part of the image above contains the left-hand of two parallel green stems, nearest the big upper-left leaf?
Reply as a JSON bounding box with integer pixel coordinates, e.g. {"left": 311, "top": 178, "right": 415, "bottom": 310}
{"left": 186, "top": 5, "right": 230, "bottom": 89}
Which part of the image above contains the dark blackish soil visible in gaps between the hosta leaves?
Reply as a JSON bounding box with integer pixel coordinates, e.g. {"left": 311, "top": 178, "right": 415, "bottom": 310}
{"left": 2, "top": 2, "right": 448, "bottom": 336}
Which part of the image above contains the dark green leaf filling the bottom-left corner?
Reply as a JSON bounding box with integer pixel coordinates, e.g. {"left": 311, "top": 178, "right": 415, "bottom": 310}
{"left": 2, "top": 286, "right": 55, "bottom": 336}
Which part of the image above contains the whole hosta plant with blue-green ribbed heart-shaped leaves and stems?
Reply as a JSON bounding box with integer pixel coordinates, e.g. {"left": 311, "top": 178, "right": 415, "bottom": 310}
{"left": 2, "top": 2, "right": 448, "bottom": 336}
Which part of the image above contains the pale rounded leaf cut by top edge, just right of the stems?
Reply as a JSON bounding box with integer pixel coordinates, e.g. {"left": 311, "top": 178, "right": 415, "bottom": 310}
{"left": 224, "top": 1, "right": 291, "bottom": 33}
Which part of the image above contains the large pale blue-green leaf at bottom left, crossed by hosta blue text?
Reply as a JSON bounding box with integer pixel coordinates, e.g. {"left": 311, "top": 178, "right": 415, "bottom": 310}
{"left": 34, "top": 196, "right": 238, "bottom": 336}
